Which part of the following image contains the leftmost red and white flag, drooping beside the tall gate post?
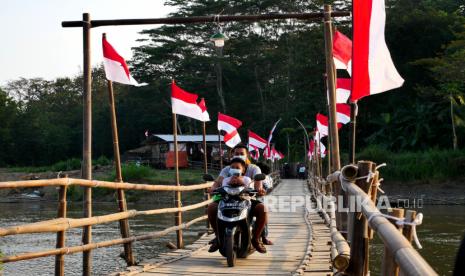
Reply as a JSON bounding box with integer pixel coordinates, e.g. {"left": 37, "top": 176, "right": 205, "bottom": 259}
{"left": 102, "top": 34, "right": 147, "bottom": 86}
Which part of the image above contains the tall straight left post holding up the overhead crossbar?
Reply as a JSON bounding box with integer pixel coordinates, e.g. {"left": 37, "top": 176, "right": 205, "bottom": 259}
{"left": 82, "top": 13, "right": 92, "bottom": 275}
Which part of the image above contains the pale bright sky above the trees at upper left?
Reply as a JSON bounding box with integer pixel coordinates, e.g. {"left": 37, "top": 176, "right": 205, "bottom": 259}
{"left": 0, "top": 0, "right": 174, "bottom": 85}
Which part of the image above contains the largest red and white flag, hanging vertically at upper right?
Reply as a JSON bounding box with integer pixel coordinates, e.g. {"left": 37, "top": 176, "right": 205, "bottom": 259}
{"left": 351, "top": 0, "right": 404, "bottom": 102}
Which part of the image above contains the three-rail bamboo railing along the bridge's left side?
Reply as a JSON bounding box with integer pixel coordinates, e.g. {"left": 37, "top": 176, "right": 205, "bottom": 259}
{"left": 0, "top": 177, "right": 213, "bottom": 275}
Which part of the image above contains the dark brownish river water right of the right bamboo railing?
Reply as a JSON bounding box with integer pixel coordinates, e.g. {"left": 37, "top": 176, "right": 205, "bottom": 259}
{"left": 370, "top": 205, "right": 465, "bottom": 275}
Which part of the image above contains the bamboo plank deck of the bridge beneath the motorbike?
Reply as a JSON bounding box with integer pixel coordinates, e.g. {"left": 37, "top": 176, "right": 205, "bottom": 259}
{"left": 117, "top": 180, "right": 332, "bottom": 276}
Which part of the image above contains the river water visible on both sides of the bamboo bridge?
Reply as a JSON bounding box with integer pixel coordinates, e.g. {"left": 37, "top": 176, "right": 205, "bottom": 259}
{"left": 0, "top": 203, "right": 465, "bottom": 275}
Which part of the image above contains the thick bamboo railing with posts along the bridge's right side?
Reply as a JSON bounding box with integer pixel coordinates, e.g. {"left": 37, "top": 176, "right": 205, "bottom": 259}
{"left": 309, "top": 161, "right": 437, "bottom": 276}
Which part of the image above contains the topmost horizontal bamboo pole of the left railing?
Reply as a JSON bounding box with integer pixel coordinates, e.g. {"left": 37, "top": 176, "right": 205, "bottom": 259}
{"left": 0, "top": 178, "right": 213, "bottom": 192}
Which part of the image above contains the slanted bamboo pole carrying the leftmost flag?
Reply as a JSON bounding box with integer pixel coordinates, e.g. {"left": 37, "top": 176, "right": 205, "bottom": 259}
{"left": 102, "top": 73, "right": 135, "bottom": 266}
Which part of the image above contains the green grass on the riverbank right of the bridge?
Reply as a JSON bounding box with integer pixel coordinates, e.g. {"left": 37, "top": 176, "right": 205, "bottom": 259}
{"left": 357, "top": 146, "right": 465, "bottom": 182}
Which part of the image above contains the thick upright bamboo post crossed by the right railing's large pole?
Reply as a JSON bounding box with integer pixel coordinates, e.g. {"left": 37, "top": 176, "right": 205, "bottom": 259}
{"left": 346, "top": 161, "right": 374, "bottom": 276}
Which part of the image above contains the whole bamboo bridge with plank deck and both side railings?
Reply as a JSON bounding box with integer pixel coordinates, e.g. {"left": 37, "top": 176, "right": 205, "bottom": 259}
{"left": 0, "top": 161, "right": 437, "bottom": 275}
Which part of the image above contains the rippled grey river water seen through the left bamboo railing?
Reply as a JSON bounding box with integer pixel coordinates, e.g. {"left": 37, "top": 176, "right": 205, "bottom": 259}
{"left": 0, "top": 198, "right": 205, "bottom": 276}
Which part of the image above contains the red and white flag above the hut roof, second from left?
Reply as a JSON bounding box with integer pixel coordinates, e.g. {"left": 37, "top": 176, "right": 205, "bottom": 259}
{"left": 171, "top": 80, "right": 208, "bottom": 121}
